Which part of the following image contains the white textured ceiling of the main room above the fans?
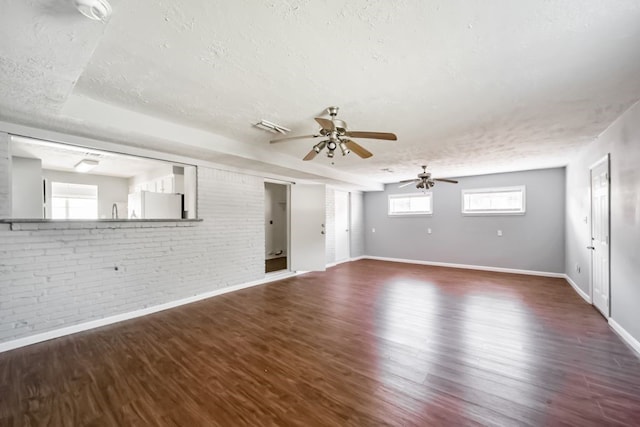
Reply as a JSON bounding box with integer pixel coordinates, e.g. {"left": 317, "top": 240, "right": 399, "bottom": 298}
{"left": 0, "top": 0, "right": 640, "bottom": 188}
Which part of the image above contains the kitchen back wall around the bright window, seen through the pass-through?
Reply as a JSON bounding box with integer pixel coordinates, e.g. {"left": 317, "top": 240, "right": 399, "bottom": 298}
{"left": 42, "top": 169, "right": 129, "bottom": 219}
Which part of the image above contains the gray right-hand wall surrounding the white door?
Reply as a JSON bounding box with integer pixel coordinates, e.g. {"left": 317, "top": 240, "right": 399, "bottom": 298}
{"left": 566, "top": 104, "right": 640, "bottom": 341}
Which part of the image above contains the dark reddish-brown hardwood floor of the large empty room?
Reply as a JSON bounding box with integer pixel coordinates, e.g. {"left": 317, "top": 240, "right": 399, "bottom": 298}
{"left": 0, "top": 260, "right": 640, "bottom": 426}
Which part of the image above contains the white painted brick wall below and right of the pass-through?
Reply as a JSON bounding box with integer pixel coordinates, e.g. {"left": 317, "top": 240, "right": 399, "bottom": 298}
{"left": 0, "top": 166, "right": 264, "bottom": 342}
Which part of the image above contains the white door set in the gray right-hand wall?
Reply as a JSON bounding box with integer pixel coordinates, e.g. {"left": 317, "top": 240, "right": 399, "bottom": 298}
{"left": 589, "top": 156, "right": 609, "bottom": 317}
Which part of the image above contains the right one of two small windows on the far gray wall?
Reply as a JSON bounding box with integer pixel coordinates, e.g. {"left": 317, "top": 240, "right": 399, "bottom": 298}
{"left": 462, "top": 185, "right": 525, "bottom": 215}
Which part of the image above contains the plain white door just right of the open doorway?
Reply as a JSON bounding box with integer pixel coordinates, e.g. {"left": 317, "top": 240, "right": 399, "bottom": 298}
{"left": 289, "top": 184, "right": 326, "bottom": 271}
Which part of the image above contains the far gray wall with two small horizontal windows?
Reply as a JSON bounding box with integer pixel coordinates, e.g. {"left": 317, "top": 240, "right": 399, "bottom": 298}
{"left": 364, "top": 168, "right": 565, "bottom": 273}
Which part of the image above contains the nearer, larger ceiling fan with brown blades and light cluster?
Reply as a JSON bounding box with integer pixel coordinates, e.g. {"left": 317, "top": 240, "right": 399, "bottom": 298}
{"left": 271, "top": 107, "right": 398, "bottom": 160}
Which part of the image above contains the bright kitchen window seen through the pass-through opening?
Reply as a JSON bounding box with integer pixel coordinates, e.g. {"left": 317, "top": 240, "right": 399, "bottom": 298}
{"left": 51, "top": 182, "right": 98, "bottom": 219}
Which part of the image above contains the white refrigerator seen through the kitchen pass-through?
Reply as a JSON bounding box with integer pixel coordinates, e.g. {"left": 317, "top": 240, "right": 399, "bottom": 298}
{"left": 127, "top": 191, "right": 182, "bottom": 219}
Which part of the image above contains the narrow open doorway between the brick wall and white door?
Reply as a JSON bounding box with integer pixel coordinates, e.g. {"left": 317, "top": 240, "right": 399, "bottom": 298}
{"left": 264, "top": 182, "right": 289, "bottom": 273}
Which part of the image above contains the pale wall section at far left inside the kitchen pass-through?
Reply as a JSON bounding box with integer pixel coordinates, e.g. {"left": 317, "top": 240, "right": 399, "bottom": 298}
{"left": 11, "top": 157, "right": 43, "bottom": 218}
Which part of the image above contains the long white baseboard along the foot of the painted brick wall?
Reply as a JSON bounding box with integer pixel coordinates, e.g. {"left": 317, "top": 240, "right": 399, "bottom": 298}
{"left": 0, "top": 272, "right": 297, "bottom": 353}
